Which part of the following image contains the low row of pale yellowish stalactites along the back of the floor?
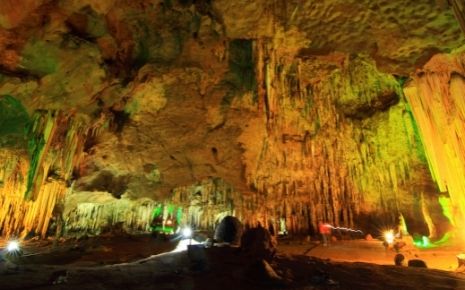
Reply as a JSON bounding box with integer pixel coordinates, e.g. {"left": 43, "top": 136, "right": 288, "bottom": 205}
{"left": 64, "top": 178, "right": 272, "bottom": 236}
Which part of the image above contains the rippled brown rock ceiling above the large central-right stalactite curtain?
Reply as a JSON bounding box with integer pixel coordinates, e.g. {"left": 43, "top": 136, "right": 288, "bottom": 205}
{"left": 213, "top": 0, "right": 463, "bottom": 74}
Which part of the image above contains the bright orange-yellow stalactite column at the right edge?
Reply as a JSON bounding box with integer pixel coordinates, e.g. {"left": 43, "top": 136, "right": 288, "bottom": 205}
{"left": 405, "top": 54, "right": 465, "bottom": 233}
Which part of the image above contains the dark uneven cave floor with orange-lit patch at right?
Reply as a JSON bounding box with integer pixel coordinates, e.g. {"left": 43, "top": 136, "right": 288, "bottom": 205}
{"left": 0, "top": 235, "right": 465, "bottom": 290}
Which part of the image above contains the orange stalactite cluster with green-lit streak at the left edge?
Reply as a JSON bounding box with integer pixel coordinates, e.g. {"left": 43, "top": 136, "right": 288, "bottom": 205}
{"left": 0, "top": 111, "right": 102, "bottom": 236}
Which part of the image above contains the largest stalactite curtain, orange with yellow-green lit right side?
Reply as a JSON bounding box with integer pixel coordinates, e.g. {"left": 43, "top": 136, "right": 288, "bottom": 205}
{"left": 247, "top": 42, "right": 421, "bottom": 232}
